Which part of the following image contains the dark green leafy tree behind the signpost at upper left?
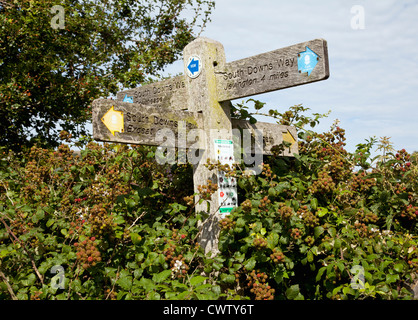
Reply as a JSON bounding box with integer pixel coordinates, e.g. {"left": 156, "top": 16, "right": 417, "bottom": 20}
{"left": 0, "top": 0, "right": 214, "bottom": 150}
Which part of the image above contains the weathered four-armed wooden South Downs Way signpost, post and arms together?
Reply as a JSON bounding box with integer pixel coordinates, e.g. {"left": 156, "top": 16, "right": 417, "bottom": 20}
{"left": 93, "top": 37, "right": 329, "bottom": 255}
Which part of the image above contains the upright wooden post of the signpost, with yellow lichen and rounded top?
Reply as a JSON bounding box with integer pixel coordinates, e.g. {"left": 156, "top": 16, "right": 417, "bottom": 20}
{"left": 183, "top": 37, "right": 232, "bottom": 255}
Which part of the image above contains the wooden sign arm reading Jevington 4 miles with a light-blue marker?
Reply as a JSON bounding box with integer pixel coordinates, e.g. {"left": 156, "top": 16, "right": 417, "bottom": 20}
{"left": 216, "top": 39, "right": 329, "bottom": 101}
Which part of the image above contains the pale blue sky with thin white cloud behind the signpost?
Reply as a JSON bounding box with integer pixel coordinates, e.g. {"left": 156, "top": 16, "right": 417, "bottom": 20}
{"left": 166, "top": 0, "right": 418, "bottom": 152}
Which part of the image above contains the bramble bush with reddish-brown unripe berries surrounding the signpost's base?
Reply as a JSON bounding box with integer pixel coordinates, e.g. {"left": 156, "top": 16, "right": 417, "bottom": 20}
{"left": 0, "top": 100, "right": 418, "bottom": 300}
